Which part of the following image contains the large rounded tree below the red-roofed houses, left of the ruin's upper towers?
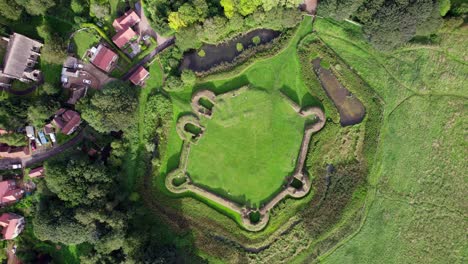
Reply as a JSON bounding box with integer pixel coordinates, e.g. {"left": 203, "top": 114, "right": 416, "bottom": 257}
{"left": 77, "top": 81, "right": 137, "bottom": 133}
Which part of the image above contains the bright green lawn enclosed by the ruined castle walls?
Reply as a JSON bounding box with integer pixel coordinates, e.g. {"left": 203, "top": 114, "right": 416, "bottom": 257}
{"left": 187, "top": 89, "right": 304, "bottom": 207}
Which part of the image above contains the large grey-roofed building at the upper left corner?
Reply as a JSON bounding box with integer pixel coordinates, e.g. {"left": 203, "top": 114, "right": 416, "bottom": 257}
{"left": 0, "top": 33, "right": 42, "bottom": 82}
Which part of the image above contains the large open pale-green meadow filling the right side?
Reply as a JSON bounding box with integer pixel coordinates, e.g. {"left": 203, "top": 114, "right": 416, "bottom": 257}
{"left": 304, "top": 17, "right": 468, "bottom": 263}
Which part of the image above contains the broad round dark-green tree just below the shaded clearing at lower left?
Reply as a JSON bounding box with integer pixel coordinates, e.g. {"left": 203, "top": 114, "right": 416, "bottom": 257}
{"left": 45, "top": 157, "right": 114, "bottom": 206}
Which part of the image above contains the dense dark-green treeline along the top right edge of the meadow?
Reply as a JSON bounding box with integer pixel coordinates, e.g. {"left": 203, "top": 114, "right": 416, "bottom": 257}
{"left": 318, "top": 0, "right": 468, "bottom": 50}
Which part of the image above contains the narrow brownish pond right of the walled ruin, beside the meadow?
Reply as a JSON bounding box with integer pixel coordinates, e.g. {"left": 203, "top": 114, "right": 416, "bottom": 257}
{"left": 312, "top": 58, "right": 366, "bottom": 126}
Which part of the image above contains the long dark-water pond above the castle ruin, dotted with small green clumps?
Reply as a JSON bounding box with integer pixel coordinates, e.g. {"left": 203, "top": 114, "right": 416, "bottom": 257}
{"left": 180, "top": 29, "right": 281, "bottom": 72}
